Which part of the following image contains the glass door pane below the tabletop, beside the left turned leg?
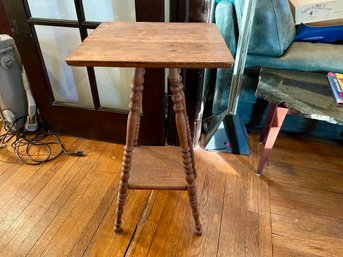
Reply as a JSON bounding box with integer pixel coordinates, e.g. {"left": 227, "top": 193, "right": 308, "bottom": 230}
{"left": 94, "top": 67, "right": 133, "bottom": 110}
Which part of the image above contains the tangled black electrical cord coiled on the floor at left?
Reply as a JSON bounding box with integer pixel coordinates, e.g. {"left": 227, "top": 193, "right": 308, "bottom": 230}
{"left": 0, "top": 117, "right": 84, "bottom": 165}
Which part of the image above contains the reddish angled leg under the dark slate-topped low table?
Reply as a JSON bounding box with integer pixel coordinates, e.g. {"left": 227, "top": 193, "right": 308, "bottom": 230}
{"left": 257, "top": 105, "right": 288, "bottom": 175}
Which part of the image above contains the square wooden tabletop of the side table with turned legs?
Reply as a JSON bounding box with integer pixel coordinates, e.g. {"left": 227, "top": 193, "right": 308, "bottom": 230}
{"left": 66, "top": 22, "right": 234, "bottom": 68}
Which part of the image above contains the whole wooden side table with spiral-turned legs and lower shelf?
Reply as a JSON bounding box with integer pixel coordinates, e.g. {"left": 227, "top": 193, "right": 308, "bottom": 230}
{"left": 66, "top": 22, "right": 233, "bottom": 235}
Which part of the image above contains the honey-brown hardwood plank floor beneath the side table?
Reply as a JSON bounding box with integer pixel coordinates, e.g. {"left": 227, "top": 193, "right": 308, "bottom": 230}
{"left": 0, "top": 131, "right": 343, "bottom": 257}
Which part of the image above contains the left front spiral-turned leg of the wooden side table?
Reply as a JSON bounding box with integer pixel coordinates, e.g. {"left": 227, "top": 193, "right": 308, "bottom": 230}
{"left": 115, "top": 68, "right": 145, "bottom": 233}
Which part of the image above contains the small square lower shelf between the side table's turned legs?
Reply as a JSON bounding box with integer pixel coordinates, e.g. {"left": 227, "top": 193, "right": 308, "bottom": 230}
{"left": 129, "top": 146, "right": 187, "bottom": 190}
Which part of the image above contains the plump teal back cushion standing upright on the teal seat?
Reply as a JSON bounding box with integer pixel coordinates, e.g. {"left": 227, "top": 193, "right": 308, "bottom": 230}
{"left": 235, "top": 0, "right": 295, "bottom": 56}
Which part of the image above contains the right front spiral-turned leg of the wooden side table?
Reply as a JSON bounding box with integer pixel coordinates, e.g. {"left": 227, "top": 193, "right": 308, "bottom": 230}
{"left": 168, "top": 68, "right": 202, "bottom": 235}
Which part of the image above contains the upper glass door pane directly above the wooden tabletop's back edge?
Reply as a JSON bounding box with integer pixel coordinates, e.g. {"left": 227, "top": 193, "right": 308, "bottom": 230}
{"left": 83, "top": 0, "right": 136, "bottom": 22}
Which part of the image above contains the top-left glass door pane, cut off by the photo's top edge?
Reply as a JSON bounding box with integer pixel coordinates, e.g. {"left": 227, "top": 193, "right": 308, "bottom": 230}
{"left": 27, "top": 0, "right": 77, "bottom": 20}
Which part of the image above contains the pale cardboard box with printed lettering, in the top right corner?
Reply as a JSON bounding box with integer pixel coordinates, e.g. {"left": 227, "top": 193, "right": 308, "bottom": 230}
{"left": 289, "top": 0, "right": 343, "bottom": 25}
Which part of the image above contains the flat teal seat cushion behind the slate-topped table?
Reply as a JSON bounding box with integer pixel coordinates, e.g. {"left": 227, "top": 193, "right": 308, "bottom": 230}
{"left": 247, "top": 42, "right": 343, "bottom": 73}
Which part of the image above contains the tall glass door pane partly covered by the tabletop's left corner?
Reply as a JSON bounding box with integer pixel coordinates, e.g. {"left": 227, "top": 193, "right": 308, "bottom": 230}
{"left": 35, "top": 25, "right": 93, "bottom": 108}
